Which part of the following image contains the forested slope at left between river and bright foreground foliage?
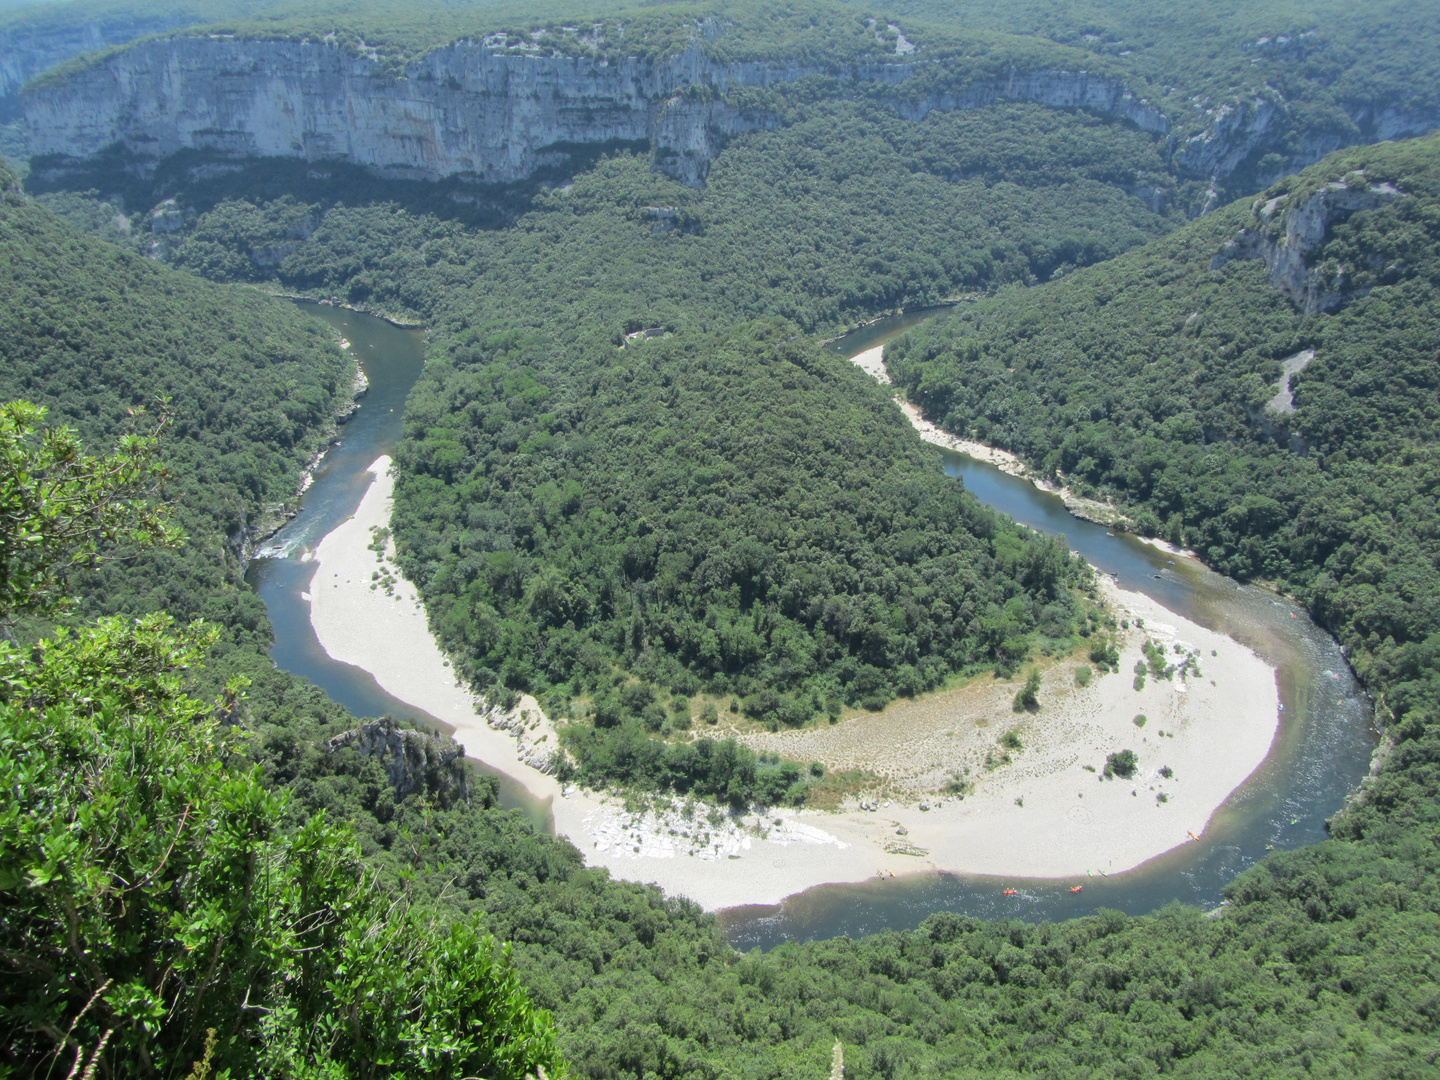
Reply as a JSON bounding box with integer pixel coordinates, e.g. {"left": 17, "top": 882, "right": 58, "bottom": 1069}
{"left": 0, "top": 158, "right": 354, "bottom": 642}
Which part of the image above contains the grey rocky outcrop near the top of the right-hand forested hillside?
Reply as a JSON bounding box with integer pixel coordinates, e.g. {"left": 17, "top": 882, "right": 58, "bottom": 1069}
{"left": 1210, "top": 173, "right": 1403, "bottom": 314}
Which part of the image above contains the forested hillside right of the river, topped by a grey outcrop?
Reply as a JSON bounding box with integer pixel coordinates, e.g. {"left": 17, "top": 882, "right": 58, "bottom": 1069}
{"left": 887, "top": 138, "right": 1440, "bottom": 743}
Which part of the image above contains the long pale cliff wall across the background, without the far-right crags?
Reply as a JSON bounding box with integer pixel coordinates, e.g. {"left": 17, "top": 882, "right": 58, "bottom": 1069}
{"left": 24, "top": 36, "right": 1166, "bottom": 184}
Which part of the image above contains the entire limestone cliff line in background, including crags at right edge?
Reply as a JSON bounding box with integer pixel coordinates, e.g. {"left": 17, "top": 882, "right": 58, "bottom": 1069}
{"left": 24, "top": 24, "right": 1440, "bottom": 192}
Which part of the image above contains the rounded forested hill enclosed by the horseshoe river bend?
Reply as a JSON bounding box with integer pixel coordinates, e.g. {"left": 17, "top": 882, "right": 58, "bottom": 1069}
{"left": 395, "top": 312, "right": 1086, "bottom": 786}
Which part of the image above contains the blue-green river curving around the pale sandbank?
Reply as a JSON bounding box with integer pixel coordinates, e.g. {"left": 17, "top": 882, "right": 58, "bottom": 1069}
{"left": 248, "top": 304, "right": 1375, "bottom": 948}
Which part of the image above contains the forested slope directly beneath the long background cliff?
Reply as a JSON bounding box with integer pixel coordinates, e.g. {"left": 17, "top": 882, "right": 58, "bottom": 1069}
{"left": 39, "top": 95, "right": 1184, "bottom": 312}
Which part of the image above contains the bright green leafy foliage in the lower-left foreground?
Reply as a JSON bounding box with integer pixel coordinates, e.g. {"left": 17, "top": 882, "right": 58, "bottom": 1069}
{"left": 0, "top": 405, "right": 564, "bottom": 1080}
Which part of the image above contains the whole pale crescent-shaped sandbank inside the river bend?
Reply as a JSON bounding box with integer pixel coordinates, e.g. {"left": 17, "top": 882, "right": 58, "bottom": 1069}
{"left": 310, "top": 458, "right": 1279, "bottom": 910}
